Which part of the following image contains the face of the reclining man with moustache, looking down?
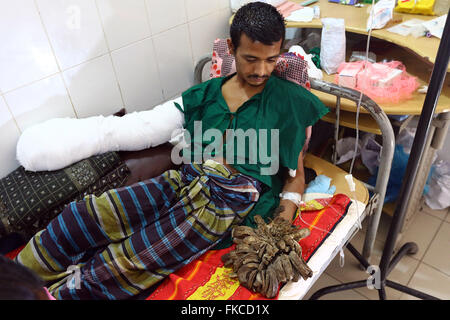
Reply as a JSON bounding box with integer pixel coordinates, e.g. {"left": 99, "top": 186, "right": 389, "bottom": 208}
{"left": 228, "top": 33, "right": 282, "bottom": 87}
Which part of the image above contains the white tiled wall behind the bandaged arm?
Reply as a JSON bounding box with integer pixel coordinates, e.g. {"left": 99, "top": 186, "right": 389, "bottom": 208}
{"left": 0, "top": 0, "right": 231, "bottom": 178}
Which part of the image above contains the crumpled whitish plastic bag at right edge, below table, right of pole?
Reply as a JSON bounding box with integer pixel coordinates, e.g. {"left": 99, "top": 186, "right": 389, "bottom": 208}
{"left": 425, "top": 160, "right": 450, "bottom": 210}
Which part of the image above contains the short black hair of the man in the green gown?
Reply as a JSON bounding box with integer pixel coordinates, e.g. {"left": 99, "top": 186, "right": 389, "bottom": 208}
{"left": 230, "top": 2, "right": 286, "bottom": 49}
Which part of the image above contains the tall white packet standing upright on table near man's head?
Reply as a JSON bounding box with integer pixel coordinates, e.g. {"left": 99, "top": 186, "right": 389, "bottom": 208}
{"left": 320, "top": 18, "right": 345, "bottom": 74}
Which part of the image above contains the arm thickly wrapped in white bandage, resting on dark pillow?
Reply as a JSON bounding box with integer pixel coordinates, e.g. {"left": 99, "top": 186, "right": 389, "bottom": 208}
{"left": 17, "top": 97, "right": 184, "bottom": 171}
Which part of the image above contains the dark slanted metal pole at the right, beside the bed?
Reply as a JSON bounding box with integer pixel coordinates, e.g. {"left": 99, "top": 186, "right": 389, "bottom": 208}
{"left": 380, "top": 11, "right": 450, "bottom": 283}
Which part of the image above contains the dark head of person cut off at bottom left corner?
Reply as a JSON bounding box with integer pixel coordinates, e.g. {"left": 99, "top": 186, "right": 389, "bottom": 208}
{"left": 0, "top": 255, "right": 44, "bottom": 300}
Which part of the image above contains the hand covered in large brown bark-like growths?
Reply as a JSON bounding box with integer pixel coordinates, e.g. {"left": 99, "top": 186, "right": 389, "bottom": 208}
{"left": 222, "top": 216, "right": 312, "bottom": 298}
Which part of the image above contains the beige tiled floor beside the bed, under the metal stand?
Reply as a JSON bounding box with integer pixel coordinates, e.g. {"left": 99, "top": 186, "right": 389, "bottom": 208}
{"left": 305, "top": 205, "right": 450, "bottom": 300}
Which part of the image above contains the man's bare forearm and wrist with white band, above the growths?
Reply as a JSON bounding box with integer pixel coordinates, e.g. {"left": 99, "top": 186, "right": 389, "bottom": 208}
{"left": 274, "top": 152, "right": 305, "bottom": 222}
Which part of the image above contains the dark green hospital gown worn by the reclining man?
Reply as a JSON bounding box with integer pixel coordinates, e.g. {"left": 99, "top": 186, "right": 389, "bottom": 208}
{"left": 177, "top": 75, "right": 329, "bottom": 247}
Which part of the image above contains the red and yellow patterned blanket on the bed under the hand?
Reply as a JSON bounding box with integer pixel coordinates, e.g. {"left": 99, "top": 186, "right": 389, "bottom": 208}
{"left": 147, "top": 194, "right": 351, "bottom": 300}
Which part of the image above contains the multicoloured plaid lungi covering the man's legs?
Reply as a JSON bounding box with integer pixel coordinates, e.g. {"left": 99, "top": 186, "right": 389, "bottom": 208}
{"left": 16, "top": 160, "right": 261, "bottom": 299}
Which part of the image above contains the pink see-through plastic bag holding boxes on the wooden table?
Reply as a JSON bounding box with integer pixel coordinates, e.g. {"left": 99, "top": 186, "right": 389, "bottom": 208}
{"left": 335, "top": 61, "right": 419, "bottom": 103}
